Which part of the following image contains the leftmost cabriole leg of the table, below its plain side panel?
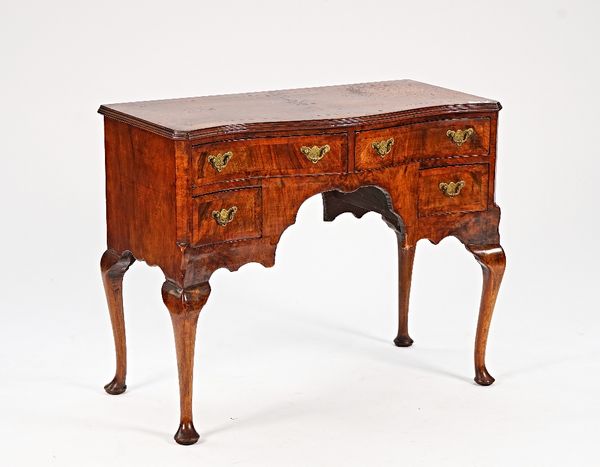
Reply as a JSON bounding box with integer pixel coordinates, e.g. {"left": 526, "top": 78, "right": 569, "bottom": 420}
{"left": 100, "top": 250, "right": 135, "bottom": 394}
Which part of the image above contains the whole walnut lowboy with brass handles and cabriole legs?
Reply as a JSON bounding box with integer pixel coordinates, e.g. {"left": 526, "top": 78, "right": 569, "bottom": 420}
{"left": 100, "top": 80, "right": 505, "bottom": 444}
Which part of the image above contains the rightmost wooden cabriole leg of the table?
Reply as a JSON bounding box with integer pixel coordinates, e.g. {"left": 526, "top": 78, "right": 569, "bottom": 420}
{"left": 467, "top": 245, "right": 506, "bottom": 386}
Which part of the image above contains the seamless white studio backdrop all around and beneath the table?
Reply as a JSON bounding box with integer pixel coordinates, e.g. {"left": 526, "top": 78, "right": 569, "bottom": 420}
{"left": 0, "top": 0, "right": 600, "bottom": 467}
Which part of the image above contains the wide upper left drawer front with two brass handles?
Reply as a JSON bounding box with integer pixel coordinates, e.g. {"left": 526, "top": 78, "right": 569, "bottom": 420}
{"left": 192, "top": 134, "right": 347, "bottom": 185}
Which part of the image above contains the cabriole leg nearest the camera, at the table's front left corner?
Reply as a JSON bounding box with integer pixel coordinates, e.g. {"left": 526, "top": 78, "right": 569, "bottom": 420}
{"left": 162, "top": 281, "right": 210, "bottom": 445}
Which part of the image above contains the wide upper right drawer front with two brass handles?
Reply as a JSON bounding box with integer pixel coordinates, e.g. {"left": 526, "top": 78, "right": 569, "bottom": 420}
{"left": 355, "top": 118, "right": 490, "bottom": 170}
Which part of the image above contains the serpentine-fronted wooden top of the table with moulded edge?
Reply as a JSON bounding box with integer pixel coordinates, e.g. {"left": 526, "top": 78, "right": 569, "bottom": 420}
{"left": 98, "top": 80, "right": 500, "bottom": 138}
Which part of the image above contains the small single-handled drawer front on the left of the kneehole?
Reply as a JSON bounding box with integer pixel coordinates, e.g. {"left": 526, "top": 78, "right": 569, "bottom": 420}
{"left": 192, "top": 187, "right": 262, "bottom": 245}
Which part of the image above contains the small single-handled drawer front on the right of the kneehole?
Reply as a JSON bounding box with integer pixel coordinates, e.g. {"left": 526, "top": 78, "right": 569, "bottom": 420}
{"left": 418, "top": 164, "right": 489, "bottom": 217}
